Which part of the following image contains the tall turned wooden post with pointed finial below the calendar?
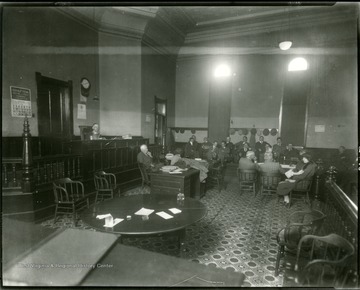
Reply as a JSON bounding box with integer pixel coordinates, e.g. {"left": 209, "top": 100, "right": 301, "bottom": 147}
{"left": 21, "top": 116, "right": 35, "bottom": 192}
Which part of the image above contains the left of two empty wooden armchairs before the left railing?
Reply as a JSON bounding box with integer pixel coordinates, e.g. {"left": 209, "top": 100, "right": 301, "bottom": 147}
{"left": 53, "top": 178, "right": 89, "bottom": 226}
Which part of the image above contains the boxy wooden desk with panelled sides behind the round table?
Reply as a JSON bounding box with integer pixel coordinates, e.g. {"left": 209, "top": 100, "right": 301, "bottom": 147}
{"left": 149, "top": 168, "right": 201, "bottom": 199}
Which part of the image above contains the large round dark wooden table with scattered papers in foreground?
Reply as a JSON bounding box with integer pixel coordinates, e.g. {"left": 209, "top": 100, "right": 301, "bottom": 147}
{"left": 80, "top": 194, "right": 207, "bottom": 246}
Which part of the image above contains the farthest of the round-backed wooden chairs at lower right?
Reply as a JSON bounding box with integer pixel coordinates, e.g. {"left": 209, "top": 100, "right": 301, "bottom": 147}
{"left": 275, "top": 210, "right": 326, "bottom": 276}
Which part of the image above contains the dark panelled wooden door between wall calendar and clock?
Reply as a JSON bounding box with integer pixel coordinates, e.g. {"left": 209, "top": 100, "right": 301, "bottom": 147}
{"left": 36, "top": 73, "right": 73, "bottom": 138}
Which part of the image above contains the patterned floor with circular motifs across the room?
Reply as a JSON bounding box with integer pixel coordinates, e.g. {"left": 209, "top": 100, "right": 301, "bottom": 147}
{"left": 42, "top": 171, "right": 306, "bottom": 287}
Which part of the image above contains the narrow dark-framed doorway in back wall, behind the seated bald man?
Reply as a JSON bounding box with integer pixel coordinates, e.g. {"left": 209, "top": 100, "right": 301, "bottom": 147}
{"left": 154, "top": 96, "right": 167, "bottom": 148}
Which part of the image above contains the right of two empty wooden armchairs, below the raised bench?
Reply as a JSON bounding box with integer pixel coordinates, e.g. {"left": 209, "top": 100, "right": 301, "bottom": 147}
{"left": 94, "top": 171, "right": 120, "bottom": 203}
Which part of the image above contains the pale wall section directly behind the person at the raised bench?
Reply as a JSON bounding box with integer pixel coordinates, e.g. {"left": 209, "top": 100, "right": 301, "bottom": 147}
{"left": 99, "top": 33, "right": 141, "bottom": 136}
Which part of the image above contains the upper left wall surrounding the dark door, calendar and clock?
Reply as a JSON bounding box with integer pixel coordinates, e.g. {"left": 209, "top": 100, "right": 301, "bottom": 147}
{"left": 2, "top": 7, "right": 99, "bottom": 136}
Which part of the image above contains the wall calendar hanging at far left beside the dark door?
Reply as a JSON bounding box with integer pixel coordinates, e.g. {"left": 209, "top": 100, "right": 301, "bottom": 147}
{"left": 10, "top": 86, "right": 32, "bottom": 118}
